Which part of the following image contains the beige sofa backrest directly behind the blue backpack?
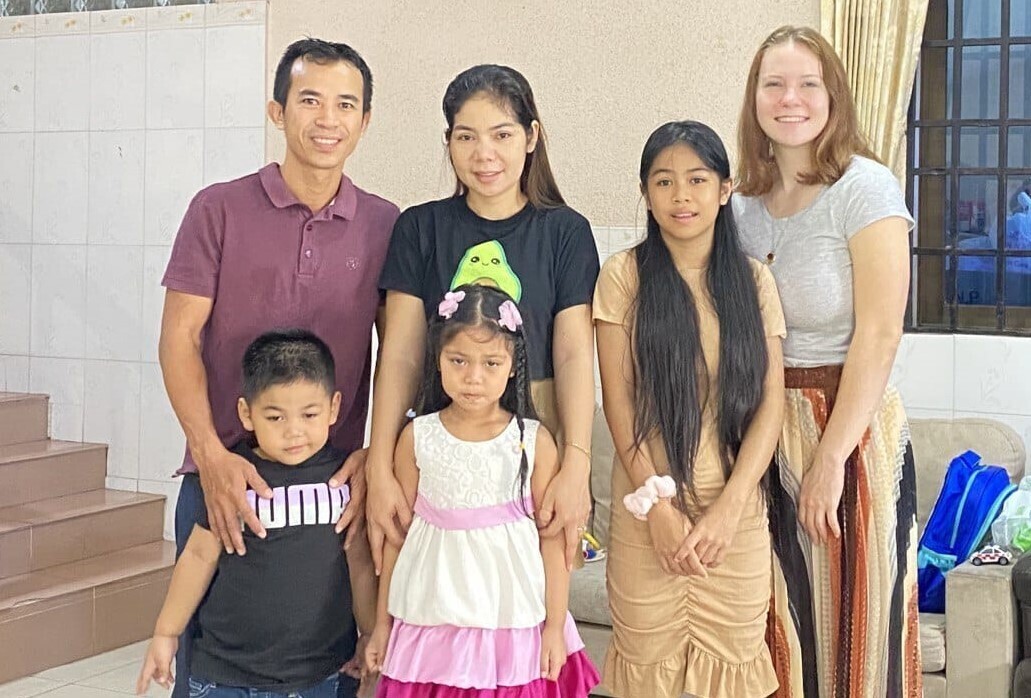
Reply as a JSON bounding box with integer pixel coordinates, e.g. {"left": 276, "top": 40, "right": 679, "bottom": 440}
{"left": 909, "top": 419, "right": 1026, "bottom": 531}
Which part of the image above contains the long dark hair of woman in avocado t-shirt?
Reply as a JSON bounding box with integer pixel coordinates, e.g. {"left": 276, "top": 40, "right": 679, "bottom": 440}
{"left": 443, "top": 64, "right": 566, "bottom": 208}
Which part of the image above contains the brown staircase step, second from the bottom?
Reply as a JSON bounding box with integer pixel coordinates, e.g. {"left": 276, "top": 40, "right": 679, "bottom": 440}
{"left": 0, "top": 490, "right": 165, "bottom": 578}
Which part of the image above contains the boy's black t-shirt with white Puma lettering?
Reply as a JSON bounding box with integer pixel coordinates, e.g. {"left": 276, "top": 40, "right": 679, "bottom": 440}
{"left": 191, "top": 443, "right": 358, "bottom": 693}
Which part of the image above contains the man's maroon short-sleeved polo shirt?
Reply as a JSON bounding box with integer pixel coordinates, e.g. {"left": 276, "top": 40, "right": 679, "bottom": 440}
{"left": 162, "top": 163, "right": 398, "bottom": 472}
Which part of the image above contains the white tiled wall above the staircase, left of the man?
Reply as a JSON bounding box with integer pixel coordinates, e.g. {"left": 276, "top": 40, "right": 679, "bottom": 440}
{"left": 0, "top": 2, "right": 266, "bottom": 534}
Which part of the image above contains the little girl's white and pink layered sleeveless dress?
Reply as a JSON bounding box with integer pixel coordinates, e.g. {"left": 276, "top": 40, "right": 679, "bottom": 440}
{"left": 376, "top": 413, "right": 599, "bottom": 698}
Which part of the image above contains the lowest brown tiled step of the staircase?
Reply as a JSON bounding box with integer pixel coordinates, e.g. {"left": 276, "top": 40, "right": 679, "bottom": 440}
{"left": 0, "top": 540, "right": 175, "bottom": 684}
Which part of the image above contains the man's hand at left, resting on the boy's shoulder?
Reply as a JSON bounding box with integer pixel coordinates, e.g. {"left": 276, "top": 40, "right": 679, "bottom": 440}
{"left": 197, "top": 448, "right": 272, "bottom": 555}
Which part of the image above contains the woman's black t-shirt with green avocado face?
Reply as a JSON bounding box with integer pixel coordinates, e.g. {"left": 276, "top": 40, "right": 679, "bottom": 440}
{"left": 379, "top": 196, "right": 599, "bottom": 380}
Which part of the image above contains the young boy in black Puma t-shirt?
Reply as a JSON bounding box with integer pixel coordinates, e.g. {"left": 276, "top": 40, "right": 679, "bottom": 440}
{"left": 136, "top": 330, "right": 376, "bottom": 698}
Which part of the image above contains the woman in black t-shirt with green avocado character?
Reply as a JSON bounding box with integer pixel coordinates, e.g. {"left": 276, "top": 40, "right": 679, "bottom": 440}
{"left": 367, "top": 65, "right": 598, "bottom": 568}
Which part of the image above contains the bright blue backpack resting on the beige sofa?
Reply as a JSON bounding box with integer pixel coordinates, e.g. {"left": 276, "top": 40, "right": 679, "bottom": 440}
{"left": 917, "top": 451, "right": 1017, "bottom": 613}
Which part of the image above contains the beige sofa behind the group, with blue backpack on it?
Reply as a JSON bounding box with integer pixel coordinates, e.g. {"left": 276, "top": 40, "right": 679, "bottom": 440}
{"left": 569, "top": 409, "right": 1026, "bottom": 698}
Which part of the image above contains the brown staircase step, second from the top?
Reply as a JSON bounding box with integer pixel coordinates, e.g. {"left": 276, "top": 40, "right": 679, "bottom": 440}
{"left": 0, "top": 440, "right": 107, "bottom": 507}
